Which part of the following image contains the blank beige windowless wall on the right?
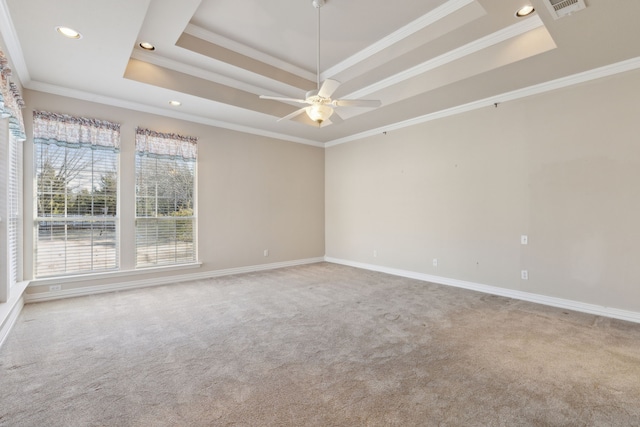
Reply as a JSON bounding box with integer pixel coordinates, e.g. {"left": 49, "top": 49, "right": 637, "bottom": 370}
{"left": 325, "top": 71, "right": 640, "bottom": 311}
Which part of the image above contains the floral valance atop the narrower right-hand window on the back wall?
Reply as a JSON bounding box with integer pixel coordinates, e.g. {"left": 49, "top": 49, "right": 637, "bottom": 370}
{"left": 136, "top": 128, "right": 198, "bottom": 161}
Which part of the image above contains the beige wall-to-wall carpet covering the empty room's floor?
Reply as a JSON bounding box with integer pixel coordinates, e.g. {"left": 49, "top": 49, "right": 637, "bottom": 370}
{"left": 0, "top": 263, "right": 640, "bottom": 427}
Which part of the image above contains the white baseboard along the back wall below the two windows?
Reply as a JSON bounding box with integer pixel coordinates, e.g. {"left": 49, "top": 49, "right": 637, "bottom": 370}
{"left": 24, "top": 257, "right": 324, "bottom": 303}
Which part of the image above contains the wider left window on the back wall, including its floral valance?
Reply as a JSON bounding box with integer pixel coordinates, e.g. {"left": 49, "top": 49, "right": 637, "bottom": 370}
{"left": 33, "top": 111, "right": 120, "bottom": 277}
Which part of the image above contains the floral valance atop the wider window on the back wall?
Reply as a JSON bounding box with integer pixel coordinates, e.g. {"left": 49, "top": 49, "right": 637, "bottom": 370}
{"left": 33, "top": 111, "right": 120, "bottom": 151}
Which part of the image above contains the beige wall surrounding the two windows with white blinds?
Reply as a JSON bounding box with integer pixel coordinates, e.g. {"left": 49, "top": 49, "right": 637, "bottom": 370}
{"left": 24, "top": 91, "right": 324, "bottom": 293}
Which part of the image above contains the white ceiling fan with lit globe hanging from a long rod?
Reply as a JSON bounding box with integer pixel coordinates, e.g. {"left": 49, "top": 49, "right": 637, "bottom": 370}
{"left": 260, "top": 0, "right": 382, "bottom": 126}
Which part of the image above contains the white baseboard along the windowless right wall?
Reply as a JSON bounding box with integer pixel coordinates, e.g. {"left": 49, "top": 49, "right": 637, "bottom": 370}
{"left": 324, "top": 257, "right": 640, "bottom": 323}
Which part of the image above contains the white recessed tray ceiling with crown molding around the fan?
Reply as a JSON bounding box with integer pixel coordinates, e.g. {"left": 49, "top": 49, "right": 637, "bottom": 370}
{"left": 0, "top": 0, "right": 640, "bottom": 145}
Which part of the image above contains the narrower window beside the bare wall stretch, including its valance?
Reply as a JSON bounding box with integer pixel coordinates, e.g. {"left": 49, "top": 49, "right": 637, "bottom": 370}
{"left": 136, "top": 128, "right": 197, "bottom": 267}
